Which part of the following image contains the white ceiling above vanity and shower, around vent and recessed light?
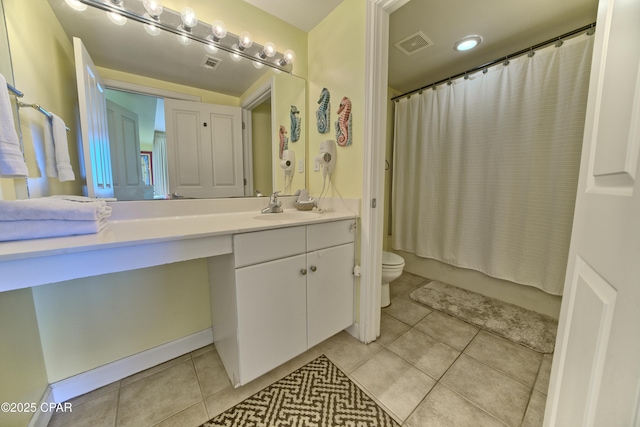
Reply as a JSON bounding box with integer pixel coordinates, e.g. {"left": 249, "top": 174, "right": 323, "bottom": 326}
{"left": 245, "top": 0, "right": 598, "bottom": 92}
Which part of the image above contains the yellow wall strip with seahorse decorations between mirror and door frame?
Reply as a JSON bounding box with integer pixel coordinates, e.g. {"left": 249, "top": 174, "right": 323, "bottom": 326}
{"left": 307, "top": 0, "right": 366, "bottom": 198}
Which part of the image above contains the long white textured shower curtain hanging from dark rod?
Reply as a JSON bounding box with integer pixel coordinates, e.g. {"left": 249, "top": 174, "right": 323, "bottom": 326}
{"left": 392, "top": 35, "right": 594, "bottom": 295}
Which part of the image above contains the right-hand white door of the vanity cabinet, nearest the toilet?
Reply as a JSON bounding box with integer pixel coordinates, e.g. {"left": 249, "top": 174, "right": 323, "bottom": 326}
{"left": 307, "top": 243, "right": 354, "bottom": 347}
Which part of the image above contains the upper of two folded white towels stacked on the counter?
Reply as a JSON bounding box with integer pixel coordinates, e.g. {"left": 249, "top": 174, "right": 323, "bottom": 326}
{"left": 0, "top": 196, "right": 112, "bottom": 223}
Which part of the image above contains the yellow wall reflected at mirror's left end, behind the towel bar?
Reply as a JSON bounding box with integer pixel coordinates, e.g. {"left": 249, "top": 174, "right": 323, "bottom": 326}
{"left": 4, "top": 0, "right": 82, "bottom": 197}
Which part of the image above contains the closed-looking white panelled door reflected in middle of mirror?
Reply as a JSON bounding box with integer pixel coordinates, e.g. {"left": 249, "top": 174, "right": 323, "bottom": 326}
{"left": 165, "top": 99, "right": 244, "bottom": 198}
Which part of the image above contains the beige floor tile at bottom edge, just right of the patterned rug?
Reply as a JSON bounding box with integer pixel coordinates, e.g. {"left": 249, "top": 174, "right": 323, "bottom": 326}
{"left": 406, "top": 384, "right": 505, "bottom": 427}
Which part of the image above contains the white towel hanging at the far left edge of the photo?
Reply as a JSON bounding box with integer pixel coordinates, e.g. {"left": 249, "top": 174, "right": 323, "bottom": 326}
{"left": 0, "top": 74, "right": 28, "bottom": 178}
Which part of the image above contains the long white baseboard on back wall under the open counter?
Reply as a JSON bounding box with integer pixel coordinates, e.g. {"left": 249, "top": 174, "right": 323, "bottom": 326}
{"left": 50, "top": 328, "right": 213, "bottom": 403}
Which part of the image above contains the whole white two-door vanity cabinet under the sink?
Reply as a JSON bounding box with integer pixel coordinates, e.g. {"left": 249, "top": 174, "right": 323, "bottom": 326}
{"left": 210, "top": 220, "right": 355, "bottom": 386}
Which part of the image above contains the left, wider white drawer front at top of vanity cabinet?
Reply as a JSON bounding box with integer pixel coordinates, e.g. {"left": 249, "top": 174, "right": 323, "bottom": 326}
{"left": 233, "top": 227, "right": 306, "bottom": 268}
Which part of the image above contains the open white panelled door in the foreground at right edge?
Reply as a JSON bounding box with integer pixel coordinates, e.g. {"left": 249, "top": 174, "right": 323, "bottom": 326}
{"left": 544, "top": 0, "right": 640, "bottom": 427}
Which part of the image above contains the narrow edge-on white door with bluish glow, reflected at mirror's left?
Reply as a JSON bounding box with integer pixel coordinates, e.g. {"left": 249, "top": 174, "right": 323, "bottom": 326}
{"left": 73, "top": 37, "right": 113, "bottom": 197}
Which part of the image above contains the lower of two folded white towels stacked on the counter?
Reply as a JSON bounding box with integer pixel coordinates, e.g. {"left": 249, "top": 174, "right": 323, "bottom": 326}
{"left": 0, "top": 219, "right": 108, "bottom": 242}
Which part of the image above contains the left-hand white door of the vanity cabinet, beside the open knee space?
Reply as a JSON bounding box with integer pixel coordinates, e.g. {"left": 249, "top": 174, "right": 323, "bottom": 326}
{"left": 236, "top": 254, "right": 307, "bottom": 385}
